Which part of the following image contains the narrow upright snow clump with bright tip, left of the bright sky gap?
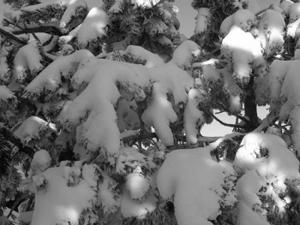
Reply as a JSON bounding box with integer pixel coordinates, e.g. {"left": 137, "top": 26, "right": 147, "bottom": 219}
{"left": 183, "top": 89, "right": 205, "bottom": 144}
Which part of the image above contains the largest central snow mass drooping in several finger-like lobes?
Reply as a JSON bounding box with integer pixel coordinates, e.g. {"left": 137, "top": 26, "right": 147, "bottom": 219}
{"left": 60, "top": 59, "right": 193, "bottom": 153}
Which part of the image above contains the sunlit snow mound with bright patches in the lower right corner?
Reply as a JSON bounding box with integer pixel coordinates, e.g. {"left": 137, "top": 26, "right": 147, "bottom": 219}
{"left": 234, "top": 133, "right": 300, "bottom": 224}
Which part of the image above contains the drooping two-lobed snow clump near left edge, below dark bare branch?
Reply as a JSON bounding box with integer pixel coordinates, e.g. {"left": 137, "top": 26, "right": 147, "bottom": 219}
{"left": 14, "top": 41, "right": 43, "bottom": 81}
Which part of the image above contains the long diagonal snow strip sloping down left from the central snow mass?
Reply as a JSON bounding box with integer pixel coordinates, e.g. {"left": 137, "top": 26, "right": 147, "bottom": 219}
{"left": 25, "top": 50, "right": 94, "bottom": 96}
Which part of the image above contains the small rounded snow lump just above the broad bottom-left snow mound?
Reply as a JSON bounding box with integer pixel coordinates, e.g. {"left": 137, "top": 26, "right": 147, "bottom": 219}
{"left": 31, "top": 150, "right": 52, "bottom": 175}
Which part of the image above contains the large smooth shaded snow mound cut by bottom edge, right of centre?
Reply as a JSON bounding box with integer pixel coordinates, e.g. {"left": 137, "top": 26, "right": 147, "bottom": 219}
{"left": 157, "top": 146, "right": 224, "bottom": 225}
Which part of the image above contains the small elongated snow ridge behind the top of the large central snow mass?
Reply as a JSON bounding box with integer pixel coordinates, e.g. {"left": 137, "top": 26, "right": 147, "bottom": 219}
{"left": 121, "top": 45, "right": 165, "bottom": 68}
